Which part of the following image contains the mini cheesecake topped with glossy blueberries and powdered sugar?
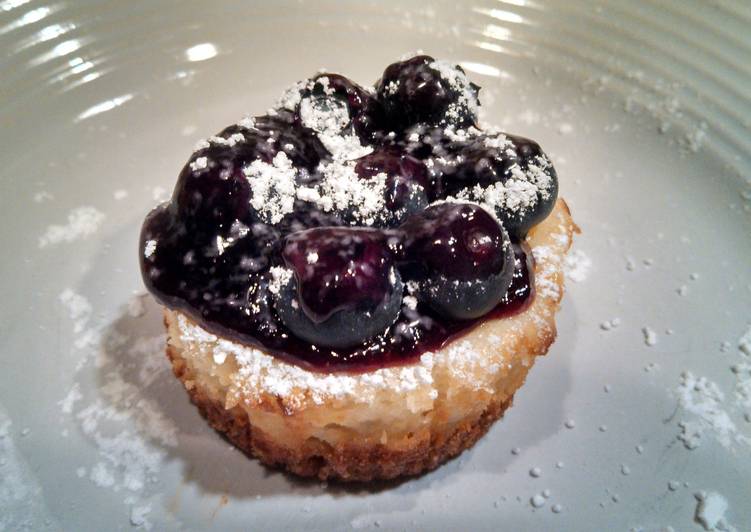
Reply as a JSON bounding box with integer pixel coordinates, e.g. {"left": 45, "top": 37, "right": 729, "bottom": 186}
{"left": 139, "top": 55, "right": 577, "bottom": 481}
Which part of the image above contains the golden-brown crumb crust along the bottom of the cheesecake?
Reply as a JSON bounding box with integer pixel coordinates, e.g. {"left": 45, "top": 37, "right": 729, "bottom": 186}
{"left": 167, "top": 345, "right": 513, "bottom": 482}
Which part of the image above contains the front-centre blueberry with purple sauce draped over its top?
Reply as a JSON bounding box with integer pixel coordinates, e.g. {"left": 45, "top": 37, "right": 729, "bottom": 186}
{"left": 276, "top": 227, "right": 403, "bottom": 348}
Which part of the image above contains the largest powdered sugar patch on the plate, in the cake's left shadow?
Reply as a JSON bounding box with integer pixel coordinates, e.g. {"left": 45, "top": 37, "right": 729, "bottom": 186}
{"left": 58, "top": 289, "right": 178, "bottom": 530}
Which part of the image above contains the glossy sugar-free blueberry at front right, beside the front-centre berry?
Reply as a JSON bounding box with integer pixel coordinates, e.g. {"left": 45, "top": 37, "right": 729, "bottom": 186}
{"left": 400, "top": 203, "right": 514, "bottom": 320}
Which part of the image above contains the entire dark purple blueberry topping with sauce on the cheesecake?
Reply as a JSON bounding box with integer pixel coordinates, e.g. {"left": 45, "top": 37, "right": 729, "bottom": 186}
{"left": 139, "top": 56, "right": 558, "bottom": 372}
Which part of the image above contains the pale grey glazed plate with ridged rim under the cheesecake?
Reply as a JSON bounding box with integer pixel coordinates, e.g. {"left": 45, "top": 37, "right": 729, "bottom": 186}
{"left": 0, "top": 0, "right": 751, "bottom": 530}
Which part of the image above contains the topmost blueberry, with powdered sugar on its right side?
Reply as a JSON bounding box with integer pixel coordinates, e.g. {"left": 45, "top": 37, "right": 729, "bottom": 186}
{"left": 376, "top": 55, "right": 479, "bottom": 131}
